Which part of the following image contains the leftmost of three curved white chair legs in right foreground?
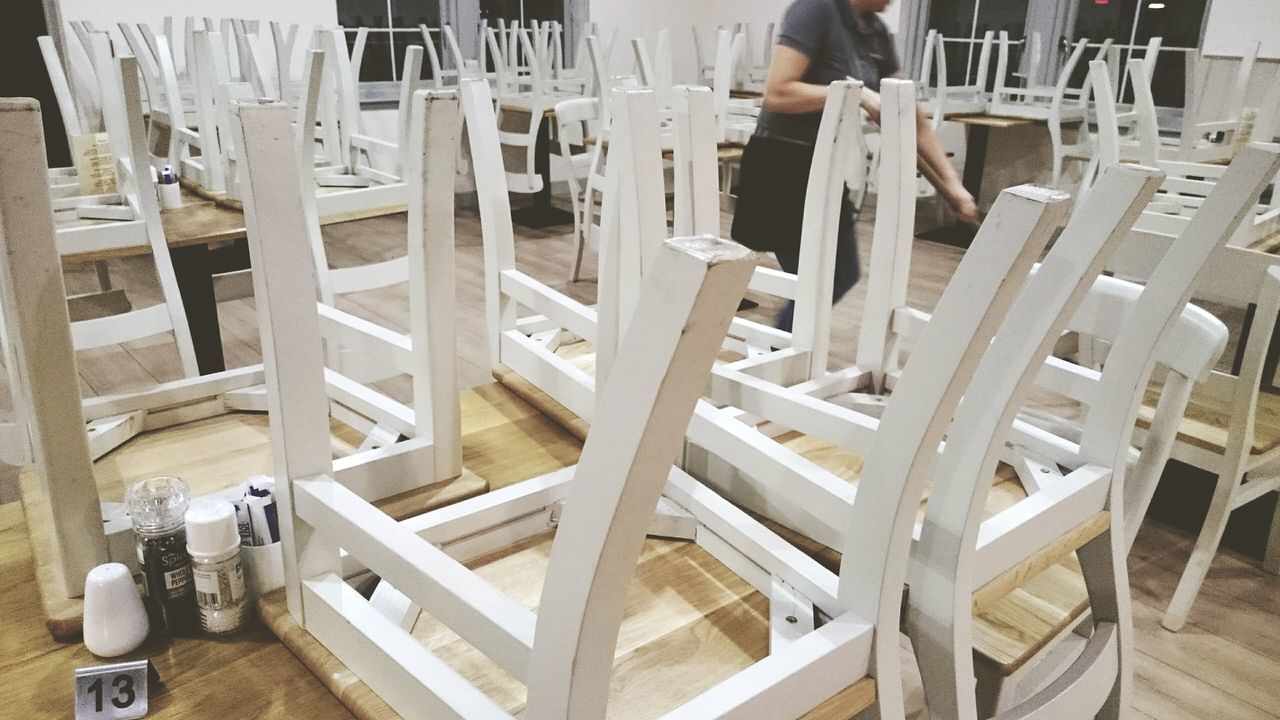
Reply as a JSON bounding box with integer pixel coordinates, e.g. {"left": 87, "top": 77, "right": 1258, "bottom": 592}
{"left": 840, "top": 179, "right": 1066, "bottom": 707}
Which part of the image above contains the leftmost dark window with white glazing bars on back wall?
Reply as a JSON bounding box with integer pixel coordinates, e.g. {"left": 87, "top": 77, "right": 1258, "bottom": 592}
{"left": 338, "top": 0, "right": 440, "bottom": 83}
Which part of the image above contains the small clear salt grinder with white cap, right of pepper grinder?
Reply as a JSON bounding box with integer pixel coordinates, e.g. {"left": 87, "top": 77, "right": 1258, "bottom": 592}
{"left": 187, "top": 498, "right": 248, "bottom": 635}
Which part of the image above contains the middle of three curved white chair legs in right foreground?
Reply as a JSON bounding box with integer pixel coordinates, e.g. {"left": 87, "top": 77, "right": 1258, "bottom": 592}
{"left": 902, "top": 162, "right": 1160, "bottom": 717}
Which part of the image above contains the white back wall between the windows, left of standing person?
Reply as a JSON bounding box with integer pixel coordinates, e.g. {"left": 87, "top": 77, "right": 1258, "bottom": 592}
{"left": 589, "top": 0, "right": 906, "bottom": 82}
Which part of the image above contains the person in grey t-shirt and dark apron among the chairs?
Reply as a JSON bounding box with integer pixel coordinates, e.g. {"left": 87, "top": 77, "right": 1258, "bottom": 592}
{"left": 732, "top": 0, "right": 978, "bottom": 331}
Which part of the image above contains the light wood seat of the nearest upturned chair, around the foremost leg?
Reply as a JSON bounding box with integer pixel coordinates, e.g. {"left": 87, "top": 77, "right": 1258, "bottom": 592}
{"left": 413, "top": 533, "right": 874, "bottom": 720}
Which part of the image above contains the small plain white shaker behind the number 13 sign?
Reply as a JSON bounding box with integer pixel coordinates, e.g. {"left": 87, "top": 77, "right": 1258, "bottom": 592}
{"left": 84, "top": 562, "right": 151, "bottom": 657}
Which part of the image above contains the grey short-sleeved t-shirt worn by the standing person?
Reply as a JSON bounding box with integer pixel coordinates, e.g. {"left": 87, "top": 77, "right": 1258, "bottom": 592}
{"left": 756, "top": 0, "right": 899, "bottom": 145}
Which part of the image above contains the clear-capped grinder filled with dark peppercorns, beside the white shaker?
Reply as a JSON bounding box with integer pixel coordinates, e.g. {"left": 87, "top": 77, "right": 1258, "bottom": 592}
{"left": 124, "top": 477, "right": 196, "bottom": 634}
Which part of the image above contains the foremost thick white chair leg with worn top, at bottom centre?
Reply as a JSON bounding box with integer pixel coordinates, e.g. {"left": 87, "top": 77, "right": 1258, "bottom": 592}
{"left": 527, "top": 241, "right": 754, "bottom": 717}
